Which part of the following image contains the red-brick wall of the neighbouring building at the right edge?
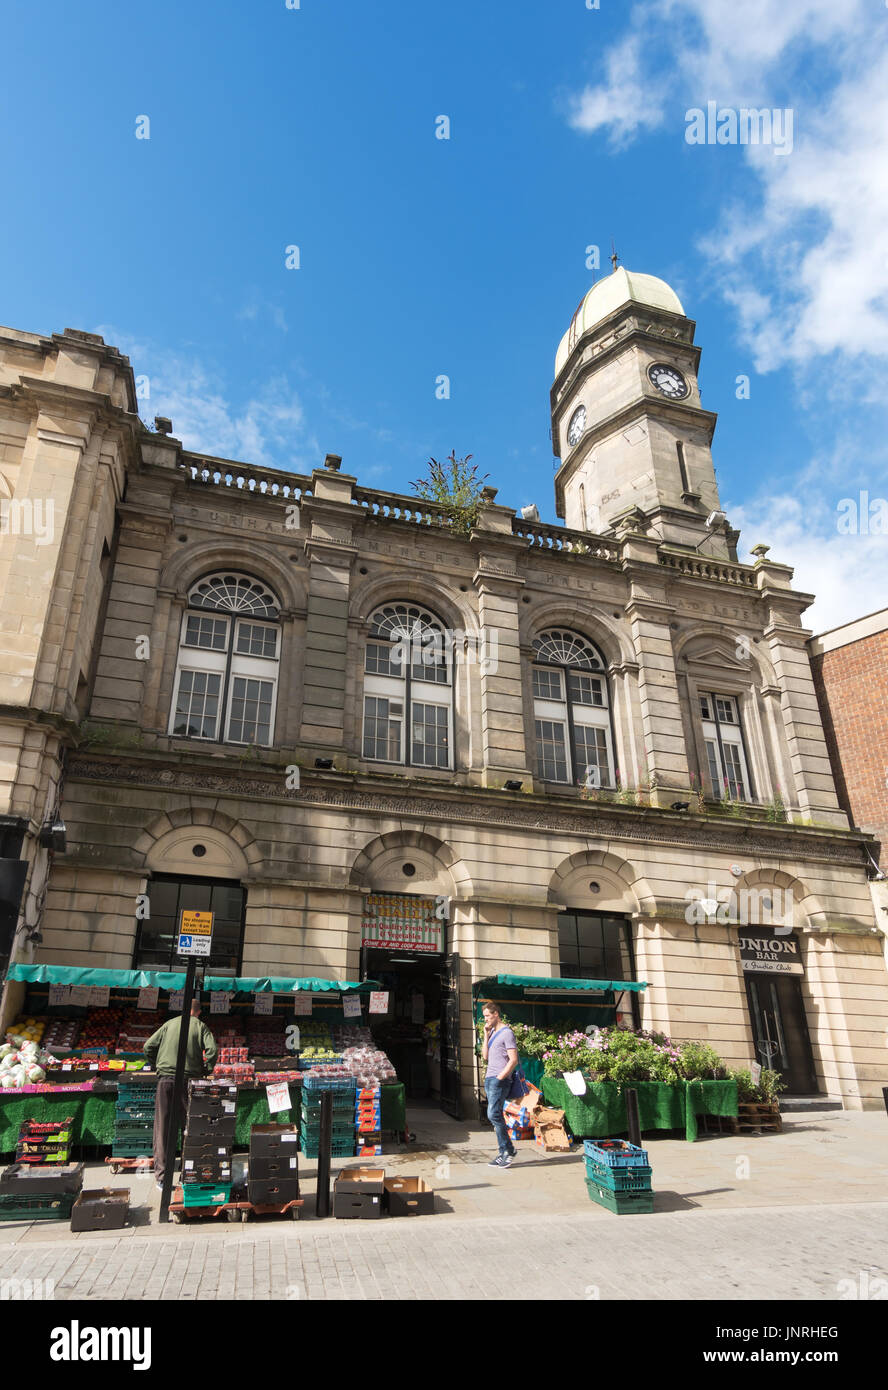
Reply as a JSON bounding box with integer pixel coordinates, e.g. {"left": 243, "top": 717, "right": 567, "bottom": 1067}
{"left": 812, "top": 630, "right": 888, "bottom": 872}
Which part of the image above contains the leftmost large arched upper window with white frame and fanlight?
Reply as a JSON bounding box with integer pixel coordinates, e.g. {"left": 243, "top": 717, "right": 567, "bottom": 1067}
{"left": 170, "top": 570, "right": 281, "bottom": 745}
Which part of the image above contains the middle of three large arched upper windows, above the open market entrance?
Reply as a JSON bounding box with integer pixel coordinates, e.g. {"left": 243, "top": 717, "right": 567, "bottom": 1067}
{"left": 363, "top": 603, "right": 453, "bottom": 767}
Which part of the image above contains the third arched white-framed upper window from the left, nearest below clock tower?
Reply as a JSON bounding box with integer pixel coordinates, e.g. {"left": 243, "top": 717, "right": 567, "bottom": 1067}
{"left": 534, "top": 628, "right": 614, "bottom": 787}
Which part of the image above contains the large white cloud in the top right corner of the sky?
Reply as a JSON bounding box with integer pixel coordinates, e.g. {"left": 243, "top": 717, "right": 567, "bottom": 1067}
{"left": 568, "top": 0, "right": 888, "bottom": 371}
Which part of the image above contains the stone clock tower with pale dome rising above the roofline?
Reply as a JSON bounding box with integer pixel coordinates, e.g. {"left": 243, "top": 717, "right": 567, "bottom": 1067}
{"left": 552, "top": 267, "right": 738, "bottom": 560}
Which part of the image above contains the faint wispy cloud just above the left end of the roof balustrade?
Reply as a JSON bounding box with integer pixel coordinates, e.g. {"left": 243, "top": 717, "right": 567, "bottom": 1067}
{"left": 96, "top": 327, "right": 320, "bottom": 471}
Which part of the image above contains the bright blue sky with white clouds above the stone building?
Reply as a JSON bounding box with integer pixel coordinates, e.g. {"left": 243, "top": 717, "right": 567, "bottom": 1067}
{"left": 0, "top": 0, "right": 888, "bottom": 630}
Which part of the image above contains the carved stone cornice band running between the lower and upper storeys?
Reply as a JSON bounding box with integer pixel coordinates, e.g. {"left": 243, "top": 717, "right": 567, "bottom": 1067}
{"left": 68, "top": 755, "right": 870, "bottom": 870}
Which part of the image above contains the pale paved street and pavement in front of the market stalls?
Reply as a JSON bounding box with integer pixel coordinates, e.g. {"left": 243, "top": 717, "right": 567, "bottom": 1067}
{"left": 0, "top": 1111, "right": 888, "bottom": 1301}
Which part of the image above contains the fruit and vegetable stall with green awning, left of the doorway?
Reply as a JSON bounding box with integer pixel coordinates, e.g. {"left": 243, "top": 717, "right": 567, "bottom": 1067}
{"left": 0, "top": 965, "right": 406, "bottom": 1155}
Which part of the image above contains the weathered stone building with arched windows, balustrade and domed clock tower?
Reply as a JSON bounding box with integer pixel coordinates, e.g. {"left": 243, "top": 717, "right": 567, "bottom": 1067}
{"left": 0, "top": 271, "right": 888, "bottom": 1108}
